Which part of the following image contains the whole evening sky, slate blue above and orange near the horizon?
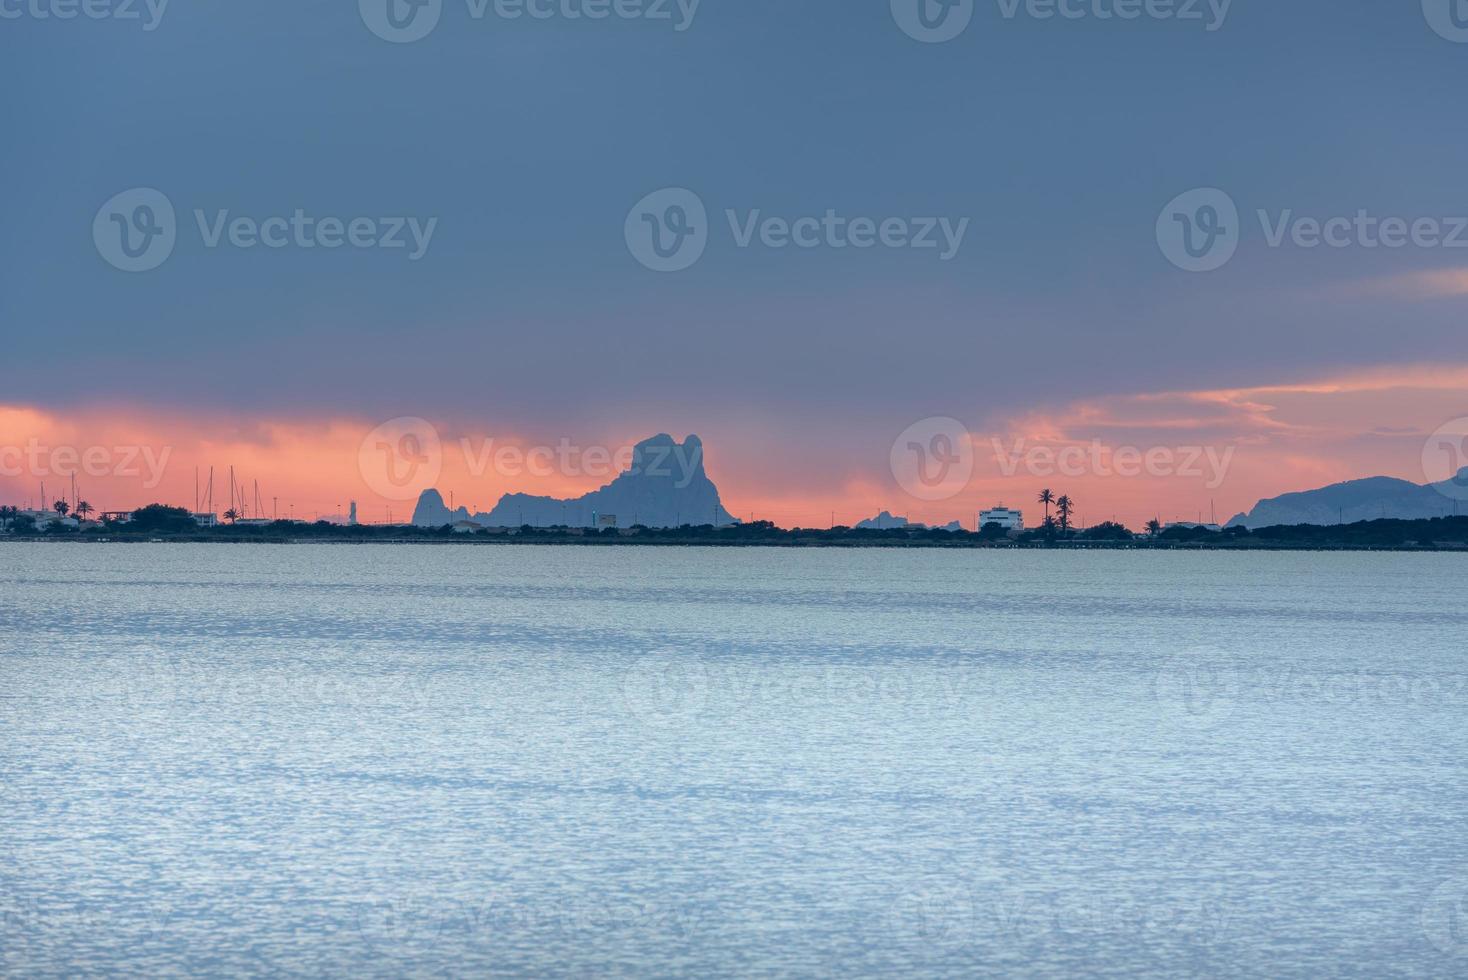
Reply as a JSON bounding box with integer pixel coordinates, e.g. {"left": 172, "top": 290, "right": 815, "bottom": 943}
{"left": 0, "top": 0, "right": 1468, "bottom": 527}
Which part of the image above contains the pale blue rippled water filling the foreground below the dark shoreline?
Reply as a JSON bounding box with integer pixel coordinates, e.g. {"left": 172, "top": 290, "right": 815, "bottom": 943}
{"left": 0, "top": 544, "right": 1468, "bottom": 977}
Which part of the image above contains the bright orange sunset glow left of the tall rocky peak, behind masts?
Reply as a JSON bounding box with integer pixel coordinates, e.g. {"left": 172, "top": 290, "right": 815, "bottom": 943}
{"left": 0, "top": 406, "right": 660, "bottom": 522}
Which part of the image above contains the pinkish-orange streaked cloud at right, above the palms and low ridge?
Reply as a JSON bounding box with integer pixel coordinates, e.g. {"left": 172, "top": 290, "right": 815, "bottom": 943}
{"left": 933, "top": 365, "right": 1468, "bottom": 525}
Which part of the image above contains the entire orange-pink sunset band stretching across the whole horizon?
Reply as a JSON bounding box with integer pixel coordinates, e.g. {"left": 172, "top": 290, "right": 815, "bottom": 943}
{"left": 0, "top": 364, "right": 1468, "bottom": 527}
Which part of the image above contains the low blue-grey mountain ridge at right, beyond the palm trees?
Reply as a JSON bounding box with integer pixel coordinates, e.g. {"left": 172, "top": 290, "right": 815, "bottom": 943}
{"left": 1227, "top": 467, "right": 1468, "bottom": 530}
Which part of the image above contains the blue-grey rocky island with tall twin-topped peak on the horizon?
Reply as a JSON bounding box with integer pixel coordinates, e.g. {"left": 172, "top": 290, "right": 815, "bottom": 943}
{"left": 413, "top": 433, "right": 738, "bottom": 528}
